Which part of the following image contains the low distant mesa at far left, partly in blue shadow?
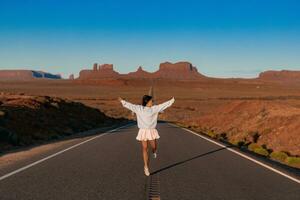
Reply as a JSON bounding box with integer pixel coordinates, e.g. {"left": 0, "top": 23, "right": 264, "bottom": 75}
{"left": 0, "top": 70, "right": 61, "bottom": 80}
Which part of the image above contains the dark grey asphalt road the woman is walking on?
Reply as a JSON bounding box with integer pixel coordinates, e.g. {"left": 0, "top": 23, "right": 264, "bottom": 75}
{"left": 0, "top": 123, "right": 300, "bottom": 200}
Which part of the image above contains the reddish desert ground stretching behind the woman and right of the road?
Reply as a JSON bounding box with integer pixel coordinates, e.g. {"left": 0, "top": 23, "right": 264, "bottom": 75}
{"left": 0, "top": 78, "right": 300, "bottom": 167}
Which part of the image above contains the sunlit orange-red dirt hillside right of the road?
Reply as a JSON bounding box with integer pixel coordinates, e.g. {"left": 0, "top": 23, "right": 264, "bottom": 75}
{"left": 187, "top": 100, "right": 300, "bottom": 156}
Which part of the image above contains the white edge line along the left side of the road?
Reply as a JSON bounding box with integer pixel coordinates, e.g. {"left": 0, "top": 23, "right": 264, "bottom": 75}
{"left": 0, "top": 124, "right": 131, "bottom": 181}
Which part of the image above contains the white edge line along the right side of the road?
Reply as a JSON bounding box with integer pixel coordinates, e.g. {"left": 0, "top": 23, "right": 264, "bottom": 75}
{"left": 168, "top": 123, "right": 300, "bottom": 184}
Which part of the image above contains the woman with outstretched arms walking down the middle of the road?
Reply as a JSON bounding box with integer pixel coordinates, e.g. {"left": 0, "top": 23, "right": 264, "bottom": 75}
{"left": 119, "top": 95, "right": 175, "bottom": 176}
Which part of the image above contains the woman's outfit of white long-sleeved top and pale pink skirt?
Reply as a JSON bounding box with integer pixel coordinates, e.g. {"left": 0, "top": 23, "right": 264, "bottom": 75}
{"left": 121, "top": 97, "right": 175, "bottom": 141}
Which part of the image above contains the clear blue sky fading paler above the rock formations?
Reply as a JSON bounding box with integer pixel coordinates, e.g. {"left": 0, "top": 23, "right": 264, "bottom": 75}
{"left": 0, "top": 0, "right": 300, "bottom": 77}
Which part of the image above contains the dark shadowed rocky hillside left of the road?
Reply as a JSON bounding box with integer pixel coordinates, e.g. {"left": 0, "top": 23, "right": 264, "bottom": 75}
{"left": 0, "top": 93, "right": 127, "bottom": 151}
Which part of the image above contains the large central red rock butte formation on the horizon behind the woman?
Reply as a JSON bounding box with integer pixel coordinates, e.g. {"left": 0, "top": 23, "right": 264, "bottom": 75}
{"left": 79, "top": 62, "right": 205, "bottom": 80}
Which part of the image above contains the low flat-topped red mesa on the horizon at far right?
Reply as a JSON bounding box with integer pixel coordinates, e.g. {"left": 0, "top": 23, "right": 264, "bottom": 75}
{"left": 259, "top": 70, "right": 300, "bottom": 82}
